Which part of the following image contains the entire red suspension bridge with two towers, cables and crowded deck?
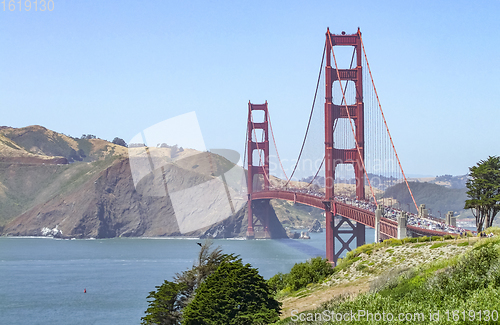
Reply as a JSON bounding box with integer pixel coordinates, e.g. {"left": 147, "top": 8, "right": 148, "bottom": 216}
{"left": 245, "top": 29, "right": 460, "bottom": 262}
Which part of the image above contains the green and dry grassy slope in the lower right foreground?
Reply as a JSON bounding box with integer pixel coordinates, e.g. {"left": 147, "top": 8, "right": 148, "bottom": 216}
{"left": 279, "top": 228, "right": 500, "bottom": 324}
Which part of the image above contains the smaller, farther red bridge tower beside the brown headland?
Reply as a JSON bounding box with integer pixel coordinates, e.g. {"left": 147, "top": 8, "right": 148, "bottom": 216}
{"left": 247, "top": 101, "right": 271, "bottom": 239}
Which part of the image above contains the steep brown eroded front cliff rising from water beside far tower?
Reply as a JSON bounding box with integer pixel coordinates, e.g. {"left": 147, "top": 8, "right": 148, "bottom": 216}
{"left": 3, "top": 158, "right": 286, "bottom": 238}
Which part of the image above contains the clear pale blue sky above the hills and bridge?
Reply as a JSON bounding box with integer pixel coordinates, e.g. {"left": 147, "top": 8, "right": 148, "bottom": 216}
{"left": 0, "top": 0, "right": 500, "bottom": 175}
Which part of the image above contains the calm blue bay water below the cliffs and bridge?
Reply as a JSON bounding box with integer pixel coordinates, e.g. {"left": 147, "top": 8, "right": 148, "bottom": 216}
{"left": 0, "top": 228, "right": 373, "bottom": 325}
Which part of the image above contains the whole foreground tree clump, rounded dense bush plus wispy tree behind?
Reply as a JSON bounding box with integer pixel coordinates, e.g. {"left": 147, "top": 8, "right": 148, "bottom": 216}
{"left": 141, "top": 241, "right": 281, "bottom": 325}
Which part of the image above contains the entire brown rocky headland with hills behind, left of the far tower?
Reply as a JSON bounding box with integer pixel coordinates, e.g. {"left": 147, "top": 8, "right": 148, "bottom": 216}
{"left": 0, "top": 126, "right": 286, "bottom": 238}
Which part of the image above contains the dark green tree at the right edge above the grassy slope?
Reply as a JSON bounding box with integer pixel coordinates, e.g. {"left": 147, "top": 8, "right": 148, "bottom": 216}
{"left": 465, "top": 156, "right": 500, "bottom": 231}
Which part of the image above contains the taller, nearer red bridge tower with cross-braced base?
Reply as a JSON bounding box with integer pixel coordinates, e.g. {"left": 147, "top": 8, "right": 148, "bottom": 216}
{"left": 324, "top": 28, "right": 365, "bottom": 263}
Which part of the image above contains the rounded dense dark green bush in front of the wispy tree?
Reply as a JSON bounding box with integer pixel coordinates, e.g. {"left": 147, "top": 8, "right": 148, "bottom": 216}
{"left": 182, "top": 259, "right": 280, "bottom": 325}
